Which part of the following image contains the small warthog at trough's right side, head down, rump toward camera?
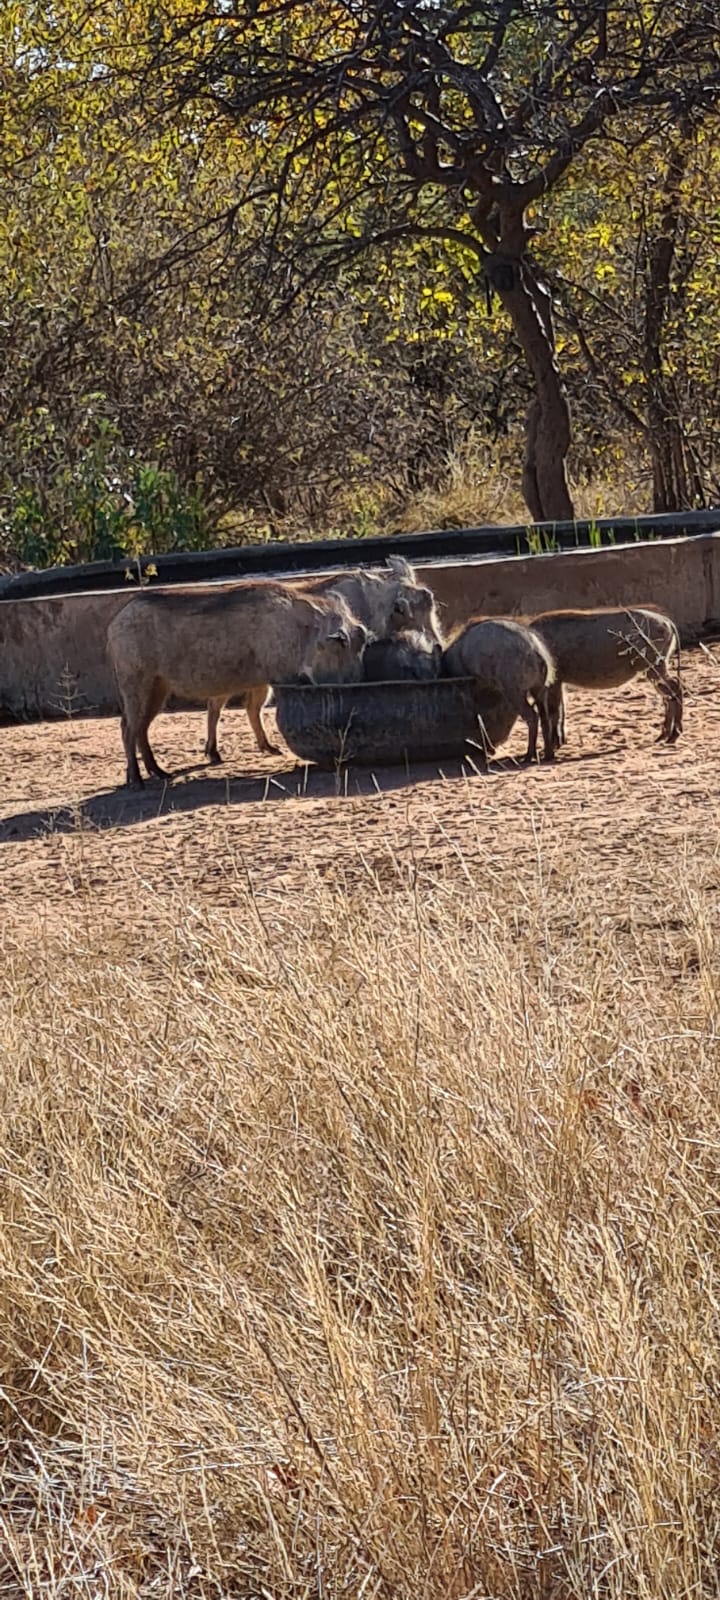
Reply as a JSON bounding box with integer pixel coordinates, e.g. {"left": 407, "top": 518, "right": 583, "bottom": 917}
{"left": 443, "top": 618, "right": 555, "bottom": 762}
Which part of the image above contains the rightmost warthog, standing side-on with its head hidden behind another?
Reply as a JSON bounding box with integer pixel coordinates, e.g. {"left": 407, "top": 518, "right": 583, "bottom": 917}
{"left": 530, "top": 606, "right": 683, "bottom": 749}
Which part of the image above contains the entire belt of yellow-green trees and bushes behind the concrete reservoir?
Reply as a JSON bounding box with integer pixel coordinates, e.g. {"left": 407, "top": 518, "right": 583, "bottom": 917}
{"left": 0, "top": 0, "right": 720, "bottom": 565}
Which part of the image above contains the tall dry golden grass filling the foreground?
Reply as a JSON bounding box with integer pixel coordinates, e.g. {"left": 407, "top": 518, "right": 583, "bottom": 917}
{"left": 0, "top": 840, "right": 720, "bottom": 1600}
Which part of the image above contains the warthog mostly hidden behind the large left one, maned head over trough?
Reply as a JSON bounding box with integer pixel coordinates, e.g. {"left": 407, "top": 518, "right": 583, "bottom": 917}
{"left": 205, "top": 555, "right": 442, "bottom": 766}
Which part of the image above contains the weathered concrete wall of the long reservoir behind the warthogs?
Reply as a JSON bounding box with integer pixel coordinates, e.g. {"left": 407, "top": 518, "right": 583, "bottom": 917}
{"left": 0, "top": 534, "right": 720, "bottom": 722}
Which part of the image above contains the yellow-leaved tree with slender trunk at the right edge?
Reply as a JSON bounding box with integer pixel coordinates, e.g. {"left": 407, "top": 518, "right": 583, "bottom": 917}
{"left": 554, "top": 112, "right": 720, "bottom": 512}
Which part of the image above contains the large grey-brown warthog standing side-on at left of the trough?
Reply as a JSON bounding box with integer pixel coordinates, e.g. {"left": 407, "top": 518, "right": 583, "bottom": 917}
{"left": 107, "top": 582, "right": 368, "bottom": 786}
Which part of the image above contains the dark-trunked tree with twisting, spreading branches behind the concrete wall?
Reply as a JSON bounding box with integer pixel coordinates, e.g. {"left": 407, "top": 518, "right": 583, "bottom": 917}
{"left": 144, "top": 0, "right": 720, "bottom": 520}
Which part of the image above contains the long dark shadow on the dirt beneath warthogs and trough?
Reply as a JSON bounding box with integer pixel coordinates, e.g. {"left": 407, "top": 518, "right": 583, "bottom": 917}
{"left": 0, "top": 746, "right": 621, "bottom": 845}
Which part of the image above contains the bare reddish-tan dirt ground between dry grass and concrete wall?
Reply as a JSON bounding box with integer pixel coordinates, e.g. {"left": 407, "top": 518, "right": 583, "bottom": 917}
{"left": 0, "top": 645, "right": 720, "bottom": 942}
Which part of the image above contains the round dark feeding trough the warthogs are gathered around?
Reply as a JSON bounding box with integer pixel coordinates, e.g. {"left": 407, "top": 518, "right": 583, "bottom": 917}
{"left": 274, "top": 678, "right": 515, "bottom": 766}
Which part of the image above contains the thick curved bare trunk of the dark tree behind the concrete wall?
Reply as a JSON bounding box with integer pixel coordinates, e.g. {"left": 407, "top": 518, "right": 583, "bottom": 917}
{"left": 485, "top": 250, "right": 574, "bottom": 522}
